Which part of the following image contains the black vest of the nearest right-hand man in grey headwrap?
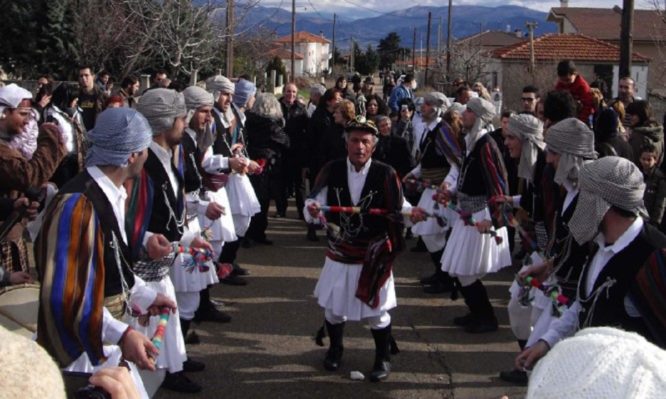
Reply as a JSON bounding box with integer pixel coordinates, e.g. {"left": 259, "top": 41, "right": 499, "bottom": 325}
{"left": 578, "top": 222, "right": 666, "bottom": 337}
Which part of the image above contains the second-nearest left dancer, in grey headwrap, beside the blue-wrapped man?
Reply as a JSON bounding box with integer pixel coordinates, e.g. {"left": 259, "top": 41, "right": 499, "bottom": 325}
{"left": 130, "top": 88, "right": 212, "bottom": 393}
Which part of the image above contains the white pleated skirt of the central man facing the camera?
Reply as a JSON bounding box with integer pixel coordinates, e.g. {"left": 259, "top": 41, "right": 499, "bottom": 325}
{"left": 314, "top": 257, "right": 398, "bottom": 321}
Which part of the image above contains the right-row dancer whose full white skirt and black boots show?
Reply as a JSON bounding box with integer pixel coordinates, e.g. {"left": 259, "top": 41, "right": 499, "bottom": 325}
{"left": 442, "top": 98, "right": 511, "bottom": 333}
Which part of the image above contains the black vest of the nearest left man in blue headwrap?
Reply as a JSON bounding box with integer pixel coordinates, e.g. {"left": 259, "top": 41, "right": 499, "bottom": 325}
{"left": 60, "top": 171, "right": 134, "bottom": 297}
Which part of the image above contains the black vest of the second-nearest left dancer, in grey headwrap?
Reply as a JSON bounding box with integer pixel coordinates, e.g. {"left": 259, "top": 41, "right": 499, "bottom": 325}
{"left": 144, "top": 149, "right": 185, "bottom": 242}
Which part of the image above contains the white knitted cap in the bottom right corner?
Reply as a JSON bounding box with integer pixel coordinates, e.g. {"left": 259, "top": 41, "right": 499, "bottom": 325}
{"left": 527, "top": 327, "right": 666, "bottom": 399}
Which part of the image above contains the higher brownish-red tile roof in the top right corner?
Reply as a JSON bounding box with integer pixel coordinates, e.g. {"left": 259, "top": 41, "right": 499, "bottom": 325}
{"left": 548, "top": 6, "right": 666, "bottom": 41}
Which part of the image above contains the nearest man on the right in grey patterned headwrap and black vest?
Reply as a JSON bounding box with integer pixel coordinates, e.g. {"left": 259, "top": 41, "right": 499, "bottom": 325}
{"left": 516, "top": 156, "right": 666, "bottom": 369}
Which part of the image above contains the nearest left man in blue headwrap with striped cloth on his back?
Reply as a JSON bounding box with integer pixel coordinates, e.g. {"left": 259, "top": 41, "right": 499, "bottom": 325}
{"left": 35, "top": 108, "right": 176, "bottom": 396}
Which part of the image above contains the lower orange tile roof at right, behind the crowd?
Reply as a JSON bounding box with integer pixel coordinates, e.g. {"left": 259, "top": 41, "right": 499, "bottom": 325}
{"left": 493, "top": 33, "right": 649, "bottom": 62}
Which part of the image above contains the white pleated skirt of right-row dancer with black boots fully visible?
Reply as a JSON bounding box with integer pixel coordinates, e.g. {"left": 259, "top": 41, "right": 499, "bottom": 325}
{"left": 442, "top": 208, "right": 511, "bottom": 277}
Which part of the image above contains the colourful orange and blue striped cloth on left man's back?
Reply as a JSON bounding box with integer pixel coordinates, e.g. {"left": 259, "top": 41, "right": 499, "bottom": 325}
{"left": 35, "top": 193, "right": 105, "bottom": 367}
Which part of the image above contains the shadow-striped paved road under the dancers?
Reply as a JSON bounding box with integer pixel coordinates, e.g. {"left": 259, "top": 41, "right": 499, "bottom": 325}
{"left": 156, "top": 211, "right": 525, "bottom": 399}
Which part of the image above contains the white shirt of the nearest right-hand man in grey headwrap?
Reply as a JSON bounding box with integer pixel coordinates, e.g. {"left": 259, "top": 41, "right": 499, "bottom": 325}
{"left": 541, "top": 217, "right": 644, "bottom": 348}
